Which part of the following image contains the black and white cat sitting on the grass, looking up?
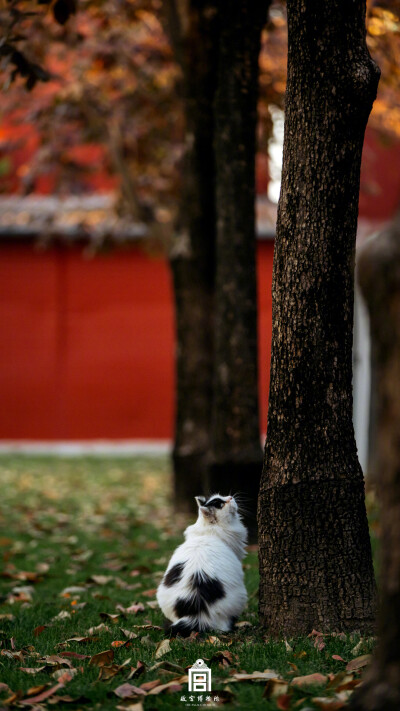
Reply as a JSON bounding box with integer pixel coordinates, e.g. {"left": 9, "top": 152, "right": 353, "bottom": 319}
{"left": 157, "top": 494, "right": 247, "bottom": 637}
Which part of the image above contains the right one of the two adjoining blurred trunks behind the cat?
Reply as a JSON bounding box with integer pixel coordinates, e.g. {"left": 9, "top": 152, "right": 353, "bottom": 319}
{"left": 208, "top": 0, "right": 269, "bottom": 530}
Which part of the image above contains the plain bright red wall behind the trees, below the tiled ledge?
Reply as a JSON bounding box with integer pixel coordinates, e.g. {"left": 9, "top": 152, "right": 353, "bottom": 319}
{"left": 0, "top": 242, "right": 273, "bottom": 440}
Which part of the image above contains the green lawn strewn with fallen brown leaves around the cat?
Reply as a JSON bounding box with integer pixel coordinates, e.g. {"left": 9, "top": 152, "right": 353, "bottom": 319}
{"left": 0, "top": 456, "right": 377, "bottom": 711}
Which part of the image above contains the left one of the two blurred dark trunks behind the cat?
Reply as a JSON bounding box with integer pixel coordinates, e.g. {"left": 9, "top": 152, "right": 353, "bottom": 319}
{"left": 163, "top": 0, "right": 217, "bottom": 511}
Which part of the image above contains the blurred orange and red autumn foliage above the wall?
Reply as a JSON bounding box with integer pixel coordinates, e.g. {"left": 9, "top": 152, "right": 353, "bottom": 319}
{"left": 0, "top": 0, "right": 400, "bottom": 220}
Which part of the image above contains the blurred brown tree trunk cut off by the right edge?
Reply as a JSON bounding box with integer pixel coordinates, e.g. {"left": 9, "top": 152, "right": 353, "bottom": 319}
{"left": 351, "top": 213, "right": 400, "bottom": 711}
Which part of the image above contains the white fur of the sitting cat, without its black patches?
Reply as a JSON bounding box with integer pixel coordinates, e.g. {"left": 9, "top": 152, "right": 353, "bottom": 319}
{"left": 157, "top": 494, "right": 247, "bottom": 631}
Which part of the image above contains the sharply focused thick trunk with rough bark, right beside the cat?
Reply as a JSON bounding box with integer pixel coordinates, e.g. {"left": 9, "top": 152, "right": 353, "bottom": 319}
{"left": 259, "top": 0, "right": 379, "bottom": 635}
